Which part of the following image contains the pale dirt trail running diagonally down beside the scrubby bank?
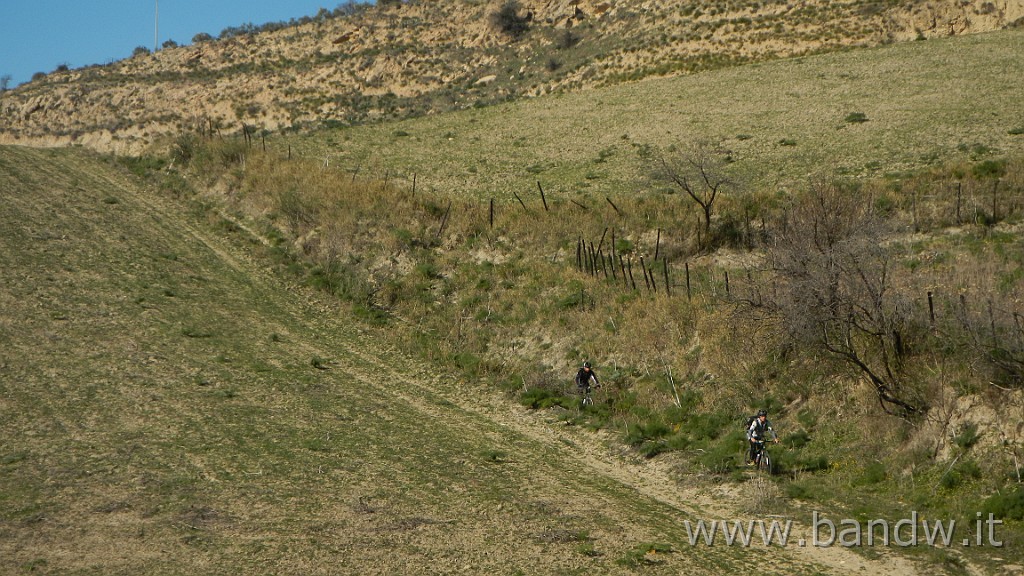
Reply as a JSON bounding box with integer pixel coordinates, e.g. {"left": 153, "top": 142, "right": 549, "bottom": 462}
{"left": 135, "top": 153, "right": 937, "bottom": 576}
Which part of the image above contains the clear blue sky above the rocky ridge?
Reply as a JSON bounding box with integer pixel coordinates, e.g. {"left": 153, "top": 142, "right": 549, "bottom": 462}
{"left": 0, "top": 0, "right": 356, "bottom": 88}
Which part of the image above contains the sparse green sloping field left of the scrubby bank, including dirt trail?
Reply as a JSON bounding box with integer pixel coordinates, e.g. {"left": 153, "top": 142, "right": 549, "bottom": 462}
{"left": 0, "top": 143, "right": 942, "bottom": 574}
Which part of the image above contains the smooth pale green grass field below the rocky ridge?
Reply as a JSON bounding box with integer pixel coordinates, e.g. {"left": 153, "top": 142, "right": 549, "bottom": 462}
{"left": 282, "top": 30, "right": 1024, "bottom": 202}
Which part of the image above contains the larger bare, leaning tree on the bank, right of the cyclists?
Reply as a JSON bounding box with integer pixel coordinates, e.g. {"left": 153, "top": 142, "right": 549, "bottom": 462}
{"left": 769, "top": 180, "right": 925, "bottom": 417}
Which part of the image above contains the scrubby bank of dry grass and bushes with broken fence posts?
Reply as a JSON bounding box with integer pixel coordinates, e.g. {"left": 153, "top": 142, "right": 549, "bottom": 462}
{"left": 155, "top": 127, "right": 1024, "bottom": 565}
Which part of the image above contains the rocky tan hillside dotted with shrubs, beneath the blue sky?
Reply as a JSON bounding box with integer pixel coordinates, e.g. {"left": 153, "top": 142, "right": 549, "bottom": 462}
{"left": 0, "top": 0, "right": 1024, "bottom": 152}
